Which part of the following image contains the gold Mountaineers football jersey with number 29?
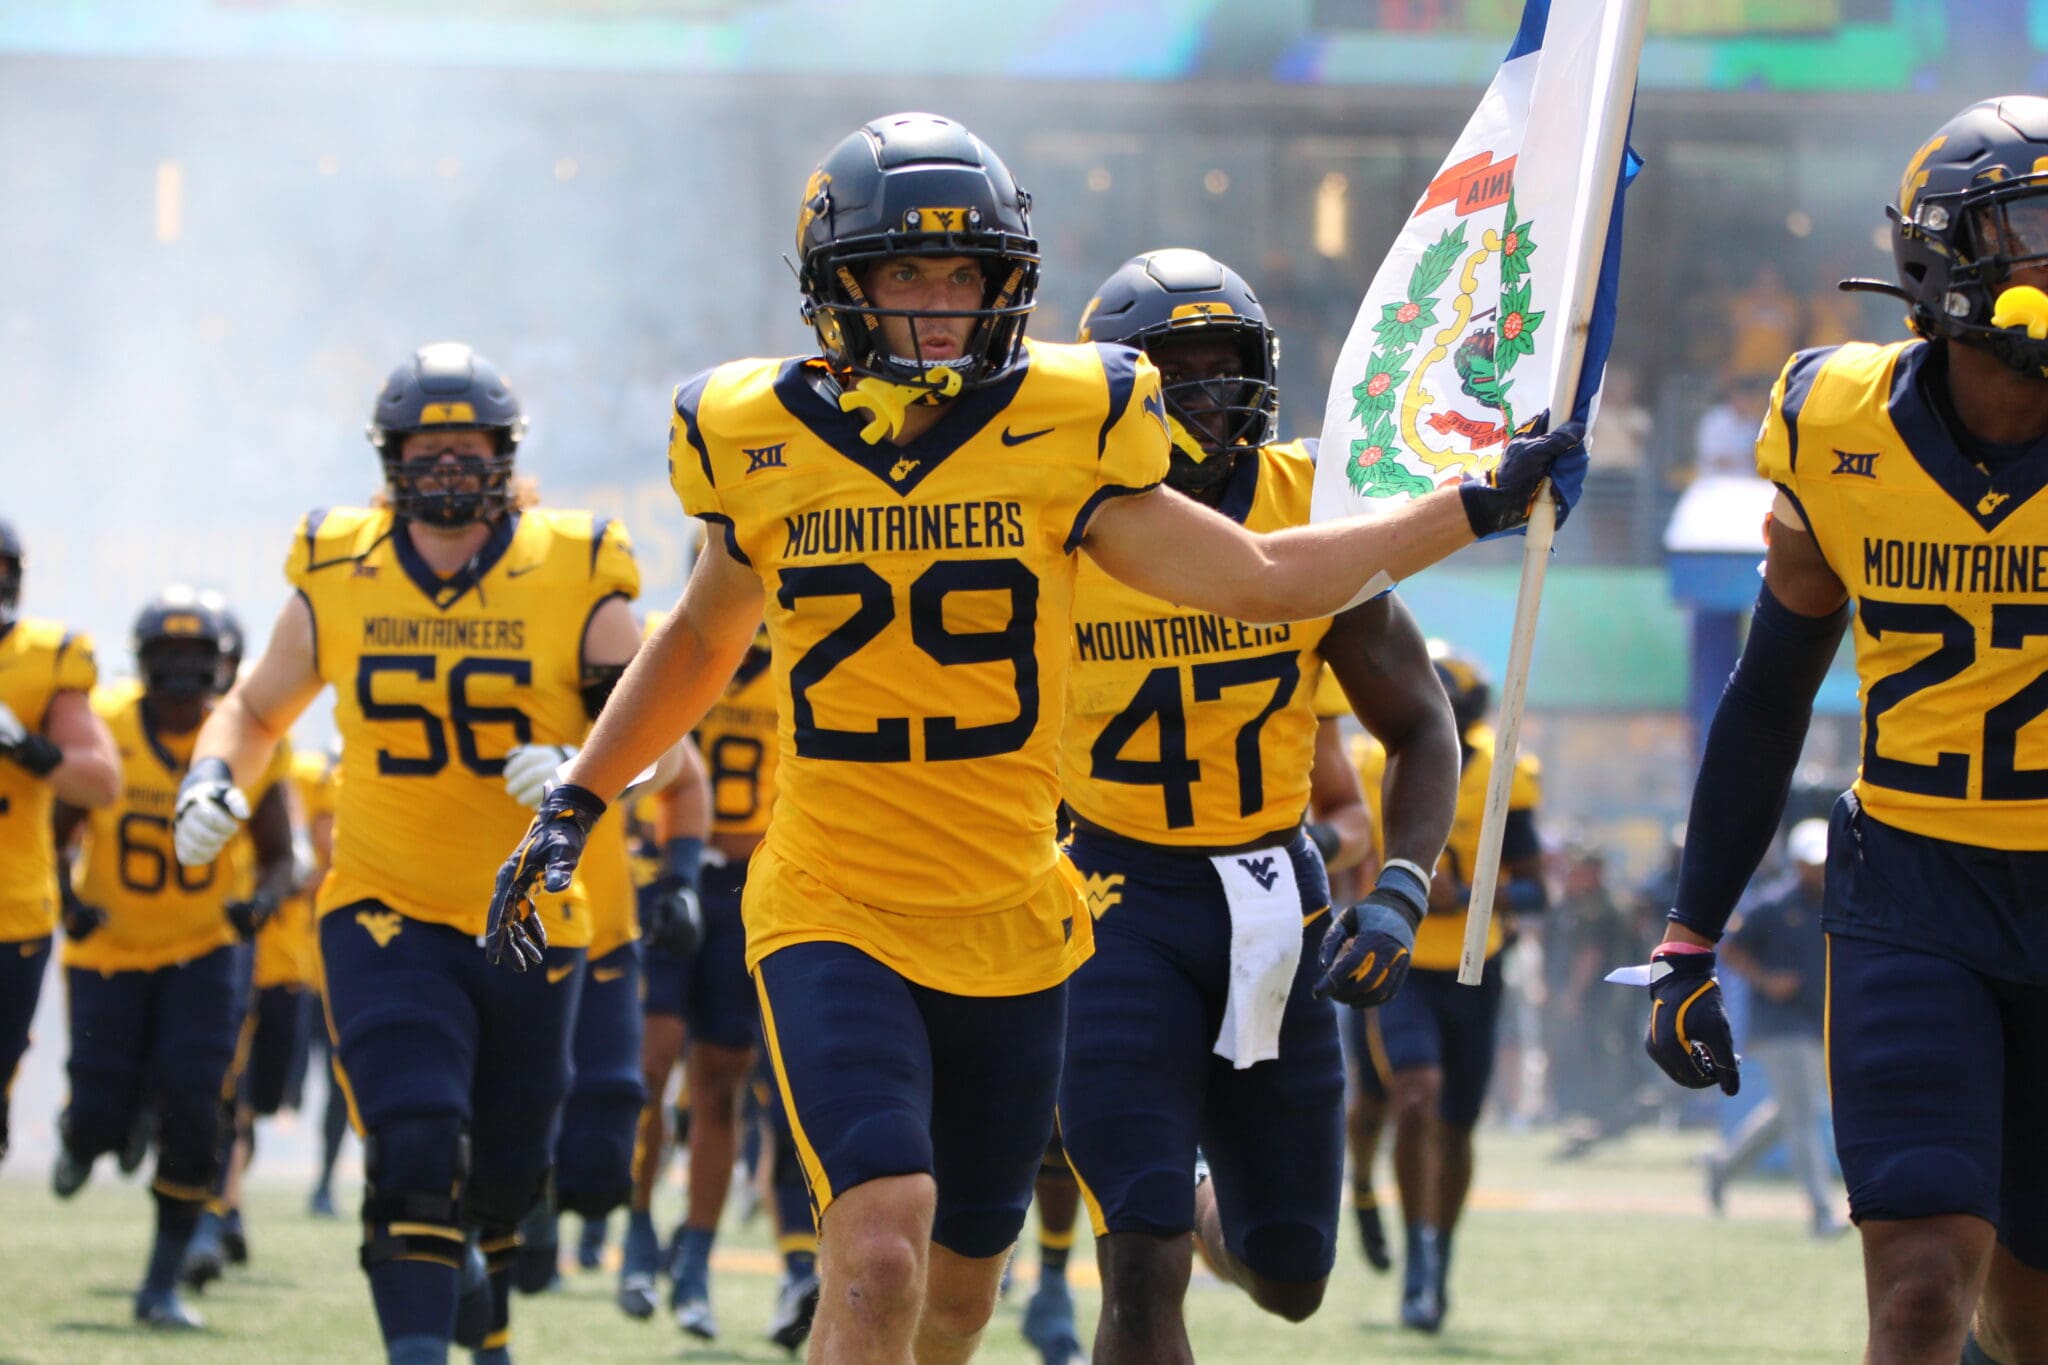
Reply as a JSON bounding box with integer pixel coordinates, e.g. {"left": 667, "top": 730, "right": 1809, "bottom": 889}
{"left": 670, "top": 342, "right": 1167, "bottom": 995}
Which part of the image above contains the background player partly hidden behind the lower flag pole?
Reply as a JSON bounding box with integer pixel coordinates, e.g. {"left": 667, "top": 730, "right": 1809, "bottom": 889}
{"left": 1346, "top": 641, "right": 1548, "bottom": 1332}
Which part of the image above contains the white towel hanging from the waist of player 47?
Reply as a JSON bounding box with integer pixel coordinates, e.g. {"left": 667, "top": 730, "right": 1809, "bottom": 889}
{"left": 1210, "top": 845, "right": 1300, "bottom": 1070}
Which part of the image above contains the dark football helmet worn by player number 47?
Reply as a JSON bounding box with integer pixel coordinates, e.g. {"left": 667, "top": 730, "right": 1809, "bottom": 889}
{"left": 1077, "top": 248, "right": 1280, "bottom": 493}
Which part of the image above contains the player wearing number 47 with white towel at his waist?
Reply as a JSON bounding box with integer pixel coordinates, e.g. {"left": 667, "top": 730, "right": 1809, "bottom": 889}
{"left": 1059, "top": 250, "right": 1458, "bottom": 1361}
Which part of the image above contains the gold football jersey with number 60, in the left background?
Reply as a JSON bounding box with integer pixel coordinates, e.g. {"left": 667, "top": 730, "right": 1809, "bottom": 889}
{"left": 63, "top": 686, "right": 238, "bottom": 972}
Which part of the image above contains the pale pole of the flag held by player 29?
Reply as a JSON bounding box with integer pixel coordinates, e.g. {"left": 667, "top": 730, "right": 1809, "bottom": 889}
{"left": 1458, "top": 0, "right": 1649, "bottom": 986}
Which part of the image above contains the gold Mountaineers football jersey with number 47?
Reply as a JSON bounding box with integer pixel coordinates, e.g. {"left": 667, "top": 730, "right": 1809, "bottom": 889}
{"left": 1061, "top": 442, "right": 1329, "bottom": 847}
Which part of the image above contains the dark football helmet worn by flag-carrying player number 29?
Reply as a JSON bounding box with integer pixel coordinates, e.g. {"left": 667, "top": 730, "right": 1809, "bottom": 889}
{"left": 797, "top": 113, "right": 1038, "bottom": 389}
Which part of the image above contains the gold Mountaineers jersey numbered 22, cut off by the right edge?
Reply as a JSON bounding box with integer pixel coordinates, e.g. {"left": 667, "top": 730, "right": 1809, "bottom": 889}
{"left": 1757, "top": 342, "right": 2048, "bottom": 849}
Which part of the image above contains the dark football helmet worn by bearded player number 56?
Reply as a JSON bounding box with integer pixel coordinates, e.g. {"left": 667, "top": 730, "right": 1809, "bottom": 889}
{"left": 369, "top": 342, "right": 526, "bottom": 526}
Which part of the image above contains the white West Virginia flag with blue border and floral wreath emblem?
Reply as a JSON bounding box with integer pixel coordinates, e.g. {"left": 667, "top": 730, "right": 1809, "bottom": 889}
{"left": 1315, "top": 0, "right": 1640, "bottom": 520}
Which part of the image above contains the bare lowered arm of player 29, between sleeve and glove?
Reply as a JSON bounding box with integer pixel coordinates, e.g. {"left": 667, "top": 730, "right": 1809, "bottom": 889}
{"left": 563, "top": 536, "right": 762, "bottom": 802}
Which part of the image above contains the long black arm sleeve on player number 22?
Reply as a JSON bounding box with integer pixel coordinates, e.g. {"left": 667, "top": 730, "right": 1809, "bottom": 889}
{"left": 1671, "top": 585, "right": 1849, "bottom": 939}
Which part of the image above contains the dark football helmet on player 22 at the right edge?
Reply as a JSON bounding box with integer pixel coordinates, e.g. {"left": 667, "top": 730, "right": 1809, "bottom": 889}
{"left": 1886, "top": 94, "right": 2048, "bottom": 379}
